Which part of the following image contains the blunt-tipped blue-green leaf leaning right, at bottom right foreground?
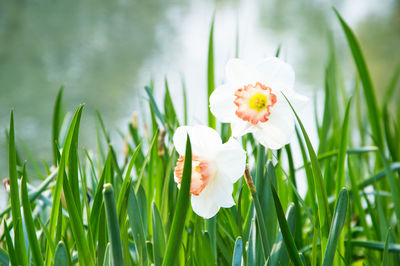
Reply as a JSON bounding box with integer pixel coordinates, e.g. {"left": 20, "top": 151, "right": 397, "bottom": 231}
{"left": 323, "top": 188, "right": 349, "bottom": 266}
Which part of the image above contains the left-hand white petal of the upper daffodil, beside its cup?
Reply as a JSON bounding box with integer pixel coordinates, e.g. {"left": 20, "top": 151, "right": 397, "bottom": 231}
{"left": 210, "top": 84, "right": 237, "bottom": 123}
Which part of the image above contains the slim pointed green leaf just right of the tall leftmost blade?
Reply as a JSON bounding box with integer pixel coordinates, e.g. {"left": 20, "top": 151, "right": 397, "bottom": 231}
{"left": 21, "top": 163, "right": 44, "bottom": 265}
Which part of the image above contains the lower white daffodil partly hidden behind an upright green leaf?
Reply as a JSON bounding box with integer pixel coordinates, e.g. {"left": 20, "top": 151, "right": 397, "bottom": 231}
{"left": 173, "top": 126, "right": 246, "bottom": 219}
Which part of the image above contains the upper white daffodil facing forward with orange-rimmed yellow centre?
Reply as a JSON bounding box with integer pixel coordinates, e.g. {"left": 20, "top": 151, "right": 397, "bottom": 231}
{"left": 210, "top": 57, "right": 307, "bottom": 149}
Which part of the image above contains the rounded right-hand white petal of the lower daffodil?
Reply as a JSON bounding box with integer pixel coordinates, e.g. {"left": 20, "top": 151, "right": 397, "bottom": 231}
{"left": 215, "top": 138, "right": 246, "bottom": 183}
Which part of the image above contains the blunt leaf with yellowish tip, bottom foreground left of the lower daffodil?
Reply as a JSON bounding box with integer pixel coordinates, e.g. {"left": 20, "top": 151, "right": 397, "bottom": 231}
{"left": 103, "top": 184, "right": 124, "bottom": 265}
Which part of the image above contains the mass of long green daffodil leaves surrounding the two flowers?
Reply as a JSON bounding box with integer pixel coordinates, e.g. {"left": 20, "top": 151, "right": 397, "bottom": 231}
{"left": 0, "top": 8, "right": 400, "bottom": 265}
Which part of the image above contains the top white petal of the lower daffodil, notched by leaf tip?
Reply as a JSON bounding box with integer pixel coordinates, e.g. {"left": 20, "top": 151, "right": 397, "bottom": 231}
{"left": 173, "top": 125, "right": 222, "bottom": 157}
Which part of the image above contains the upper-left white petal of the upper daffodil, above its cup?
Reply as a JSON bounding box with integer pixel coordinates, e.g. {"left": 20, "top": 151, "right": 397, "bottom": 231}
{"left": 225, "top": 58, "right": 258, "bottom": 89}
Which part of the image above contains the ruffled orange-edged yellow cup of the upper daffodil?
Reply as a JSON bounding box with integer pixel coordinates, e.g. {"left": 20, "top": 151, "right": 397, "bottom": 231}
{"left": 234, "top": 82, "right": 277, "bottom": 125}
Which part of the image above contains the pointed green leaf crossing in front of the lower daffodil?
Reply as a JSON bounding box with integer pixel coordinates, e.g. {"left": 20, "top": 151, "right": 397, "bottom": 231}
{"left": 162, "top": 135, "right": 192, "bottom": 266}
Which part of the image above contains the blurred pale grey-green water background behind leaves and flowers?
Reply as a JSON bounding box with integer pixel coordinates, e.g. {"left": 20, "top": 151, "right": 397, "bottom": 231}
{"left": 0, "top": 0, "right": 400, "bottom": 194}
